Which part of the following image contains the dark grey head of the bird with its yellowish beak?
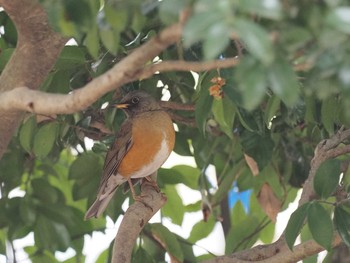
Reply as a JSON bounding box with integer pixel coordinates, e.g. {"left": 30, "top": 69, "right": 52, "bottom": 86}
{"left": 114, "top": 90, "right": 161, "bottom": 117}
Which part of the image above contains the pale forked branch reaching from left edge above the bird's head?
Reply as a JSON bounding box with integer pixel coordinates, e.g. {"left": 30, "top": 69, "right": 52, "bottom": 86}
{"left": 0, "top": 55, "right": 238, "bottom": 114}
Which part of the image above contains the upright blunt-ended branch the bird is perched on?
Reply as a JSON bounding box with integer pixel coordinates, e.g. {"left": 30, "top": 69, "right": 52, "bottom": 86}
{"left": 112, "top": 174, "right": 167, "bottom": 263}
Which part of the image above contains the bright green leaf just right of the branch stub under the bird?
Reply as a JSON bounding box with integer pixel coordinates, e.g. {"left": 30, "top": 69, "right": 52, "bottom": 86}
{"left": 162, "top": 185, "right": 185, "bottom": 226}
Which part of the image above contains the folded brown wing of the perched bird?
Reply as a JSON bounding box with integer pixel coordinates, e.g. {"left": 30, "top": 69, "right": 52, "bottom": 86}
{"left": 98, "top": 119, "right": 133, "bottom": 193}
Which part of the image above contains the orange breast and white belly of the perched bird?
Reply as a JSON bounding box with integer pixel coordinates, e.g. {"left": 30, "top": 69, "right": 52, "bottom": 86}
{"left": 118, "top": 111, "right": 175, "bottom": 177}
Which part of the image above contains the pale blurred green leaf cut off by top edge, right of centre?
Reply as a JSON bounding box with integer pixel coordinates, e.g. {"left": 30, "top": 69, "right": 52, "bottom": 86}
{"left": 238, "top": 0, "right": 282, "bottom": 19}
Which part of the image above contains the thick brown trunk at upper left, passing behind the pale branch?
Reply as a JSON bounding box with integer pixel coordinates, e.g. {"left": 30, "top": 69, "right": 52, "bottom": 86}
{"left": 0, "top": 0, "right": 66, "bottom": 158}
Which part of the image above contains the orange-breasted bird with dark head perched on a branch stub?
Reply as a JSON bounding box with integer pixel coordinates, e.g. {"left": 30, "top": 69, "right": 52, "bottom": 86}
{"left": 85, "top": 90, "right": 175, "bottom": 220}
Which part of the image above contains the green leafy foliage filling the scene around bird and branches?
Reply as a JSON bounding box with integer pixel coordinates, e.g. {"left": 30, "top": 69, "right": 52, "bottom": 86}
{"left": 0, "top": 0, "right": 350, "bottom": 262}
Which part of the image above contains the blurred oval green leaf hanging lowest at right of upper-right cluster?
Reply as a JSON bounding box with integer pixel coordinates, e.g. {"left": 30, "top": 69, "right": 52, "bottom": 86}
{"left": 268, "top": 58, "right": 300, "bottom": 106}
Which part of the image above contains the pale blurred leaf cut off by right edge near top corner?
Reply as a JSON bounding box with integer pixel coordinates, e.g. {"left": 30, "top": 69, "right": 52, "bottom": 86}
{"left": 326, "top": 6, "right": 350, "bottom": 34}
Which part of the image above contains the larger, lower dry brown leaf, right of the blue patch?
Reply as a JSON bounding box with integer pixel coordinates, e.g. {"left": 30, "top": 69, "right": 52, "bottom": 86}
{"left": 258, "top": 183, "right": 282, "bottom": 223}
